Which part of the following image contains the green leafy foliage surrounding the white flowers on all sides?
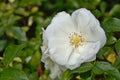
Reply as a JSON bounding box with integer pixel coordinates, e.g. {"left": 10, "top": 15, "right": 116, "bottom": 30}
{"left": 0, "top": 0, "right": 120, "bottom": 80}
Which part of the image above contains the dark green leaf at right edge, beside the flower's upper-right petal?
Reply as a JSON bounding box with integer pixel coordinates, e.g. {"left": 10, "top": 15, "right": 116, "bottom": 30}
{"left": 102, "top": 18, "right": 120, "bottom": 32}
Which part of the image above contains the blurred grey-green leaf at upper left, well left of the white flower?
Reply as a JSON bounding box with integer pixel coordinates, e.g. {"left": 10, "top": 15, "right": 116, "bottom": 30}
{"left": 11, "top": 27, "right": 27, "bottom": 41}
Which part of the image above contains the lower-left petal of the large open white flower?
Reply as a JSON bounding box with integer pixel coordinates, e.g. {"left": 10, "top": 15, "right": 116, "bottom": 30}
{"left": 49, "top": 44, "right": 72, "bottom": 65}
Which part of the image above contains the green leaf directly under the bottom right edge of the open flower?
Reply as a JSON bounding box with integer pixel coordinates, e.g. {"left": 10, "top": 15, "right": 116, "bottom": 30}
{"left": 71, "top": 63, "right": 93, "bottom": 73}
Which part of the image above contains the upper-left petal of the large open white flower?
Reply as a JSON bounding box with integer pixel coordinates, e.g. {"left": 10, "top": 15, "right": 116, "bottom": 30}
{"left": 45, "top": 12, "right": 76, "bottom": 38}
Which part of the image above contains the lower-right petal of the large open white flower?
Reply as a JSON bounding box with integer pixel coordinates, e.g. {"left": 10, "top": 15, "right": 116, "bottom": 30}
{"left": 66, "top": 42, "right": 100, "bottom": 70}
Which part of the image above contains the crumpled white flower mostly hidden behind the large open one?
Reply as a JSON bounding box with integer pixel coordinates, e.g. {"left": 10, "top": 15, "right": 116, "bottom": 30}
{"left": 41, "top": 30, "right": 67, "bottom": 80}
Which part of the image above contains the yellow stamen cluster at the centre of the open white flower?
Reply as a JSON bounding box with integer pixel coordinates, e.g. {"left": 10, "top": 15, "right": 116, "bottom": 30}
{"left": 69, "top": 33, "right": 82, "bottom": 48}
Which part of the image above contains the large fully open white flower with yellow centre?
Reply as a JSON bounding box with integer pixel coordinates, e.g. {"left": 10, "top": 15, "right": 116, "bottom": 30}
{"left": 43, "top": 8, "right": 106, "bottom": 79}
